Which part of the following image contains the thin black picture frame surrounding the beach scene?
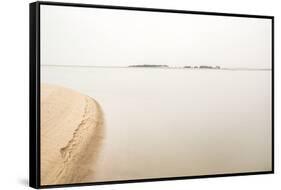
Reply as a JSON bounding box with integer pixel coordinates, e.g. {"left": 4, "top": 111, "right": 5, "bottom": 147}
{"left": 29, "top": 1, "right": 274, "bottom": 188}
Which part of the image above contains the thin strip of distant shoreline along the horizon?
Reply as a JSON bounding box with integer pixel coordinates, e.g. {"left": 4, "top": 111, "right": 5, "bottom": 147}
{"left": 41, "top": 65, "right": 272, "bottom": 71}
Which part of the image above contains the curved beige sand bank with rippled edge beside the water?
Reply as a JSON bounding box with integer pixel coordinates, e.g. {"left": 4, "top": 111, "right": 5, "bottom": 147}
{"left": 41, "top": 84, "right": 104, "bottom": 185}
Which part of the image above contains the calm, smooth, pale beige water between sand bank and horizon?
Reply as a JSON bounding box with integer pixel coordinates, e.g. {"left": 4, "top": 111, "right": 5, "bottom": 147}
{"left": 41, "top": 66, "right": 272, "bottom": 181}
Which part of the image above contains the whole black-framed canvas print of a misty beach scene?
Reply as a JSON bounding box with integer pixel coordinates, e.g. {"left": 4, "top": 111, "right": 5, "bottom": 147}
{"left": 30, "top": 2, "right": 274, "bottom": 188}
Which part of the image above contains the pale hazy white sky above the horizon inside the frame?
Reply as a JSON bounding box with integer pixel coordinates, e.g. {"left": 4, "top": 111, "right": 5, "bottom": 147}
{"left": 41, "top": 5, "right": 271, "bottom": 68}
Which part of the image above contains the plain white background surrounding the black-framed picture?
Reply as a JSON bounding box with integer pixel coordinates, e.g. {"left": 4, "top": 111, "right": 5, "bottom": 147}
{"left": 0, "top": 0, "right": 276, "bottom": 190}
